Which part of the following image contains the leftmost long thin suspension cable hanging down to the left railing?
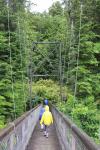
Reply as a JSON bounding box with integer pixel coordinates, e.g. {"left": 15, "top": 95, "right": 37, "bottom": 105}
{"left": 7, "top": 0, "right": 16, "bottom": 119}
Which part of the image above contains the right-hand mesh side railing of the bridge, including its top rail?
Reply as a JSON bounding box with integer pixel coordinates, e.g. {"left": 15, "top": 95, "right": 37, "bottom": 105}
{"left": 51, "top": 106, "right": 100, "bottom": 150}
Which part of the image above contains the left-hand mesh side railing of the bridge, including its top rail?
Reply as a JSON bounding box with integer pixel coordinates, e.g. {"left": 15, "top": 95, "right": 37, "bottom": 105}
{"left": 0, "top": 105, "right": 41, "bottom": 150}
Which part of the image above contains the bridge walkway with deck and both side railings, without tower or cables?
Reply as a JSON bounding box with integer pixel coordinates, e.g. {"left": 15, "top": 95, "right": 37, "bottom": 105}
{"left": 0, "top": 105, "right": 99, "bottom": 150}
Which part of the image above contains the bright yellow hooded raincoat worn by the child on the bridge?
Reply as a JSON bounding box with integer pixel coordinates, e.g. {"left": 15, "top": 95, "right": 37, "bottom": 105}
{"left": 40, "top": 106, "right": 53, "bottom": 126}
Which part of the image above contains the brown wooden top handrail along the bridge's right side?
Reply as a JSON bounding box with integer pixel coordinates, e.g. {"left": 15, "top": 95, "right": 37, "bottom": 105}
{"left": 51, "top": 104, "right": 99, "bottom": 150}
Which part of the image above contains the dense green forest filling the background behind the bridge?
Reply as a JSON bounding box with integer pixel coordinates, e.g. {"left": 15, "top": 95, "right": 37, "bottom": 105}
{"left": 0, "top": 0, "right": 100, "bottom": 144}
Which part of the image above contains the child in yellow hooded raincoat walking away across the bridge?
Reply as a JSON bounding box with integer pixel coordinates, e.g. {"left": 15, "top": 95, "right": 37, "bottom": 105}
{"left": 40, "top": 106, "right": 53, "bottom": 138}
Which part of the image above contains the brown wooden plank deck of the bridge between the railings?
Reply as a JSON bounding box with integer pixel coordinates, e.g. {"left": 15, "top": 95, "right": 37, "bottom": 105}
{"left": 26, "top": 123, "right": 61, "bottom": 150}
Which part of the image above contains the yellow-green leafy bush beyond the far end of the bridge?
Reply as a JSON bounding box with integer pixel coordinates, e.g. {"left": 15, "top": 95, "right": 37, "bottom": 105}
{"left": 32, "top": 80, "right": 67, "bottom": 103}
